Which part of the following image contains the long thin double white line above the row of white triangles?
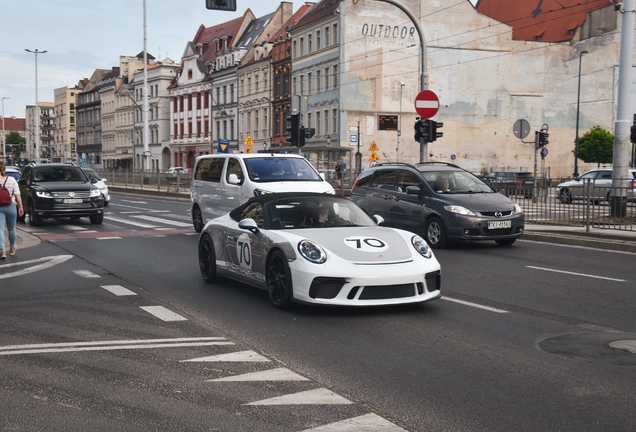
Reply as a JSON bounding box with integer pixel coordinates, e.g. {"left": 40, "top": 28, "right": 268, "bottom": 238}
{"left": 0, "top": 337, "right": 234, "bottom": 355}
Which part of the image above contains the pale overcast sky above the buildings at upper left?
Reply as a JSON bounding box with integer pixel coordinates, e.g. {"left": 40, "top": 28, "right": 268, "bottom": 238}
{"left": 0, "top": 0, "right": 304, "bottom": 117}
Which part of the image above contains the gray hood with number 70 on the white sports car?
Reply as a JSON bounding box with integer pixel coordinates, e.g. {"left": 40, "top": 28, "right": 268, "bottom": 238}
{"left": 288, "top": 227, "right": 414, "bottom": 264}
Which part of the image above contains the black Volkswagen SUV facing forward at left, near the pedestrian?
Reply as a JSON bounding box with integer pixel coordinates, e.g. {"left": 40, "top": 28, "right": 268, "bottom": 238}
{"left": 18, "top": 164, "right": 104, "bottom": 226}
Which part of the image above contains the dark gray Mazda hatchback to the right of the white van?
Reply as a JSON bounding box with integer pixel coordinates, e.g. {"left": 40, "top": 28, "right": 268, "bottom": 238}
{"left": 351, "top": 162, "right": 524, "bottom": 248}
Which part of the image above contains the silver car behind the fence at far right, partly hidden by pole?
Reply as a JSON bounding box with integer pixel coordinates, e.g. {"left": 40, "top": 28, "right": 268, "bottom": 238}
{"left": 557, "top": 168, "right": 636, "bottom": 204}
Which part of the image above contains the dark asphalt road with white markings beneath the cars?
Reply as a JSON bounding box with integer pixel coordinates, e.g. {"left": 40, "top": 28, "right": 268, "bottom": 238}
{"left": 0, "top": 194, "right": 636, "bottom": 431}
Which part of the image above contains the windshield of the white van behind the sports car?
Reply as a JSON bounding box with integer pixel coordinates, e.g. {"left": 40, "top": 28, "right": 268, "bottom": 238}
{"left": 243, "top": 156, "right": 322, "bottom": 182}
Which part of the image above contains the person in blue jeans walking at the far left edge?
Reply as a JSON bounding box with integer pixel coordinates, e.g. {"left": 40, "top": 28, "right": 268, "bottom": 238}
{"left": 0, "top": 162, "right": 24, "bottom": 260}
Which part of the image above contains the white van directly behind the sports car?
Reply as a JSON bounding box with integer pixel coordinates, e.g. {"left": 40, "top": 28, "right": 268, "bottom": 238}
{"left": 190, "top": 153, "right": 335, "bottom": 232}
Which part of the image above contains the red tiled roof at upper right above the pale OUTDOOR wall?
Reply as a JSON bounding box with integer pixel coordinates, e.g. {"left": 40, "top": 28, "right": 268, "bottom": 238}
{"left": 475, "top": 0, "right": 611, "bottom": 42}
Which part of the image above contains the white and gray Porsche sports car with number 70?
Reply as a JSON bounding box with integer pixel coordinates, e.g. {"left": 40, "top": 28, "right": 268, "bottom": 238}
{"left": 199, "top": 192, "right": 441, "bottom": 309}
